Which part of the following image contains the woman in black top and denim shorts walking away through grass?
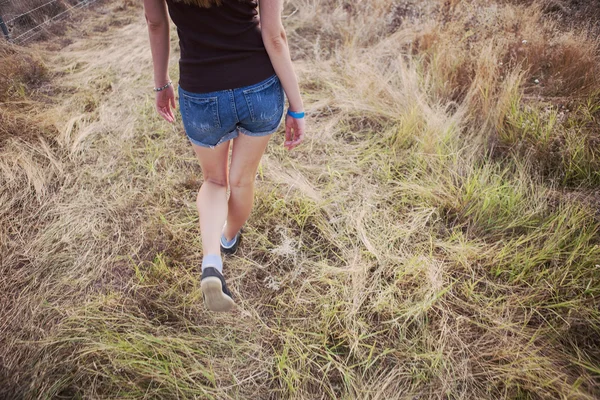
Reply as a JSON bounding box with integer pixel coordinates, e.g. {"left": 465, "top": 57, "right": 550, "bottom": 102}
{"left": 144, "top": 0, "right": 304, "bottom": 311}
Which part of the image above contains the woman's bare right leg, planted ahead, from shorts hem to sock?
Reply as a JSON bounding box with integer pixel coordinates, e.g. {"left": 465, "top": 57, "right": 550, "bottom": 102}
{"left": 224, "top": 133, "right": 273, "bottom": 240}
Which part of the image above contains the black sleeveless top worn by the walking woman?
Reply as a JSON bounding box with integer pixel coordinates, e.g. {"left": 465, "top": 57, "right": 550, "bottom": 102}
{"left": 166, "top": 0, "right": 275, "bottom": 93}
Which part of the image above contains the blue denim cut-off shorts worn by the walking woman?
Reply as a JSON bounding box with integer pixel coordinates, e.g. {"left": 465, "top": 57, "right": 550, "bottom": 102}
{"left": 179, "top": 75, "right": 285, "bottom": 148}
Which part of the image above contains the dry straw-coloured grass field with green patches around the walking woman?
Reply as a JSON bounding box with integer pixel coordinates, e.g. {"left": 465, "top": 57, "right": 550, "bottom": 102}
{"left": 0, "top": 0, "right": 600, "bottom": 400}
